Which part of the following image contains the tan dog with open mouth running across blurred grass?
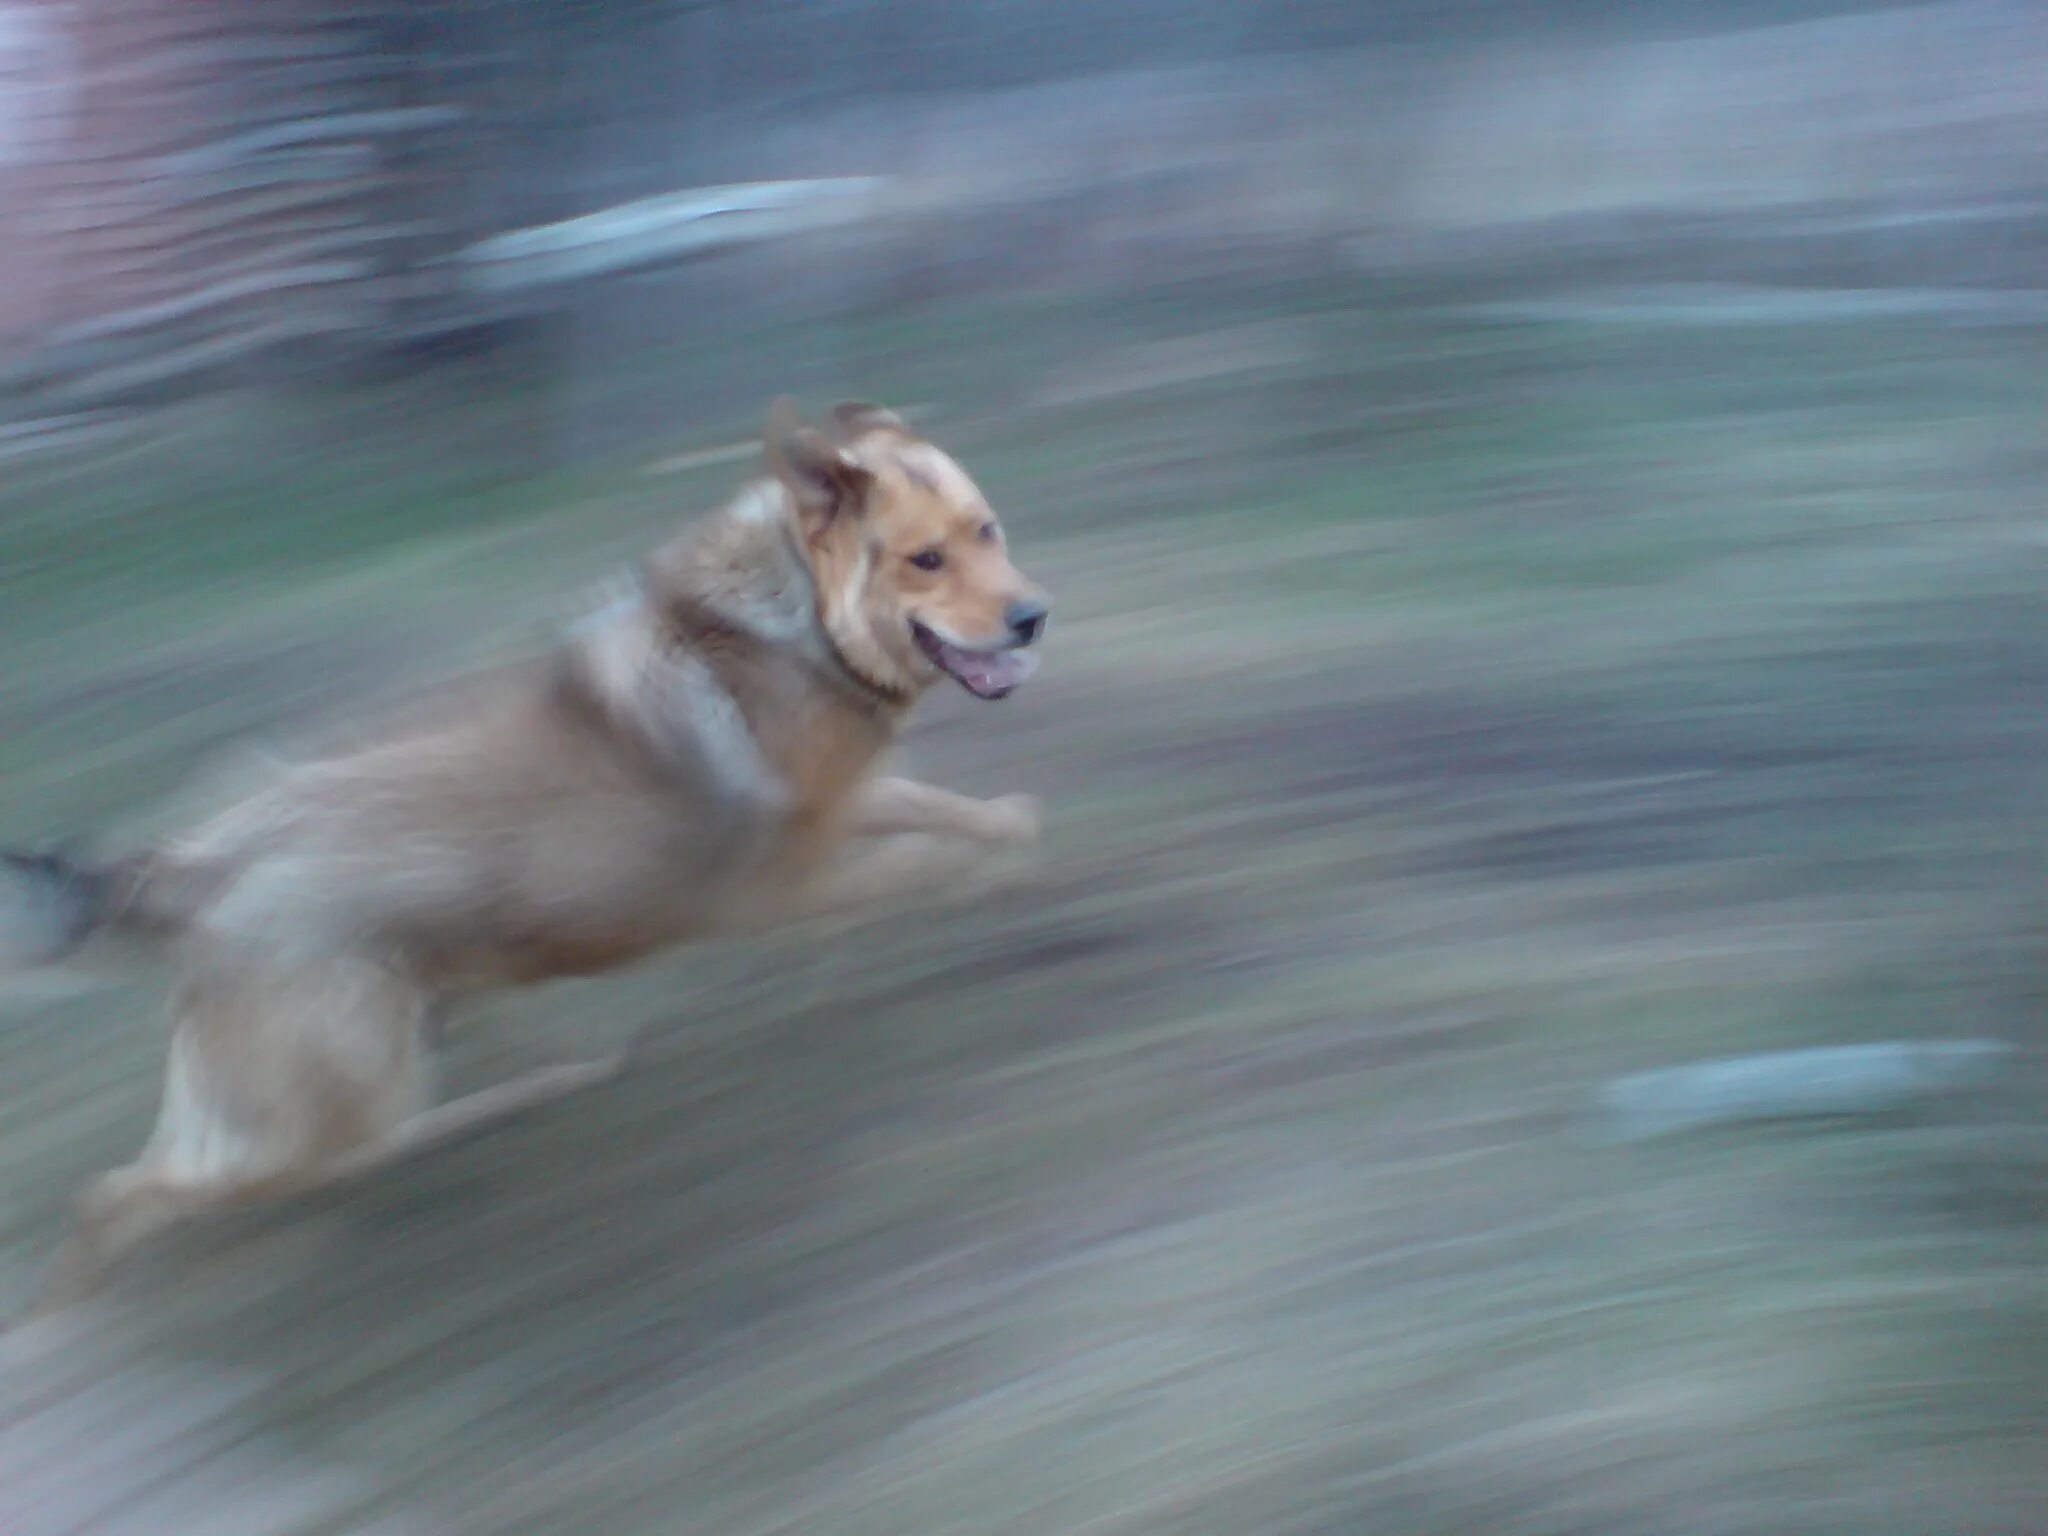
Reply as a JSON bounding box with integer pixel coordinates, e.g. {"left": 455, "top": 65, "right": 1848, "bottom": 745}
{"left": 0, "top": 403, "right": 1047, "bottom": 1305}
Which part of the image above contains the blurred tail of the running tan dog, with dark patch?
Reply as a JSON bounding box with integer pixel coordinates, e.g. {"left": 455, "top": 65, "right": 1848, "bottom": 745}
{"left": 0, "top": 850, "right": 190, "bottom": 975}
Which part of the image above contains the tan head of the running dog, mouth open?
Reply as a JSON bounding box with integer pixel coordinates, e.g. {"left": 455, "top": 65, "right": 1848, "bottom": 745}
{"left": 768, "top": 401, "right": 1047, "bottom": 698}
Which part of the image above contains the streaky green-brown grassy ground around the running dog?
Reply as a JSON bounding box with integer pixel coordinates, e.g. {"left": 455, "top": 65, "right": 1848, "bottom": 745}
{"left": 0, "top": 276, "right": 2048, "bottom": 1536}
